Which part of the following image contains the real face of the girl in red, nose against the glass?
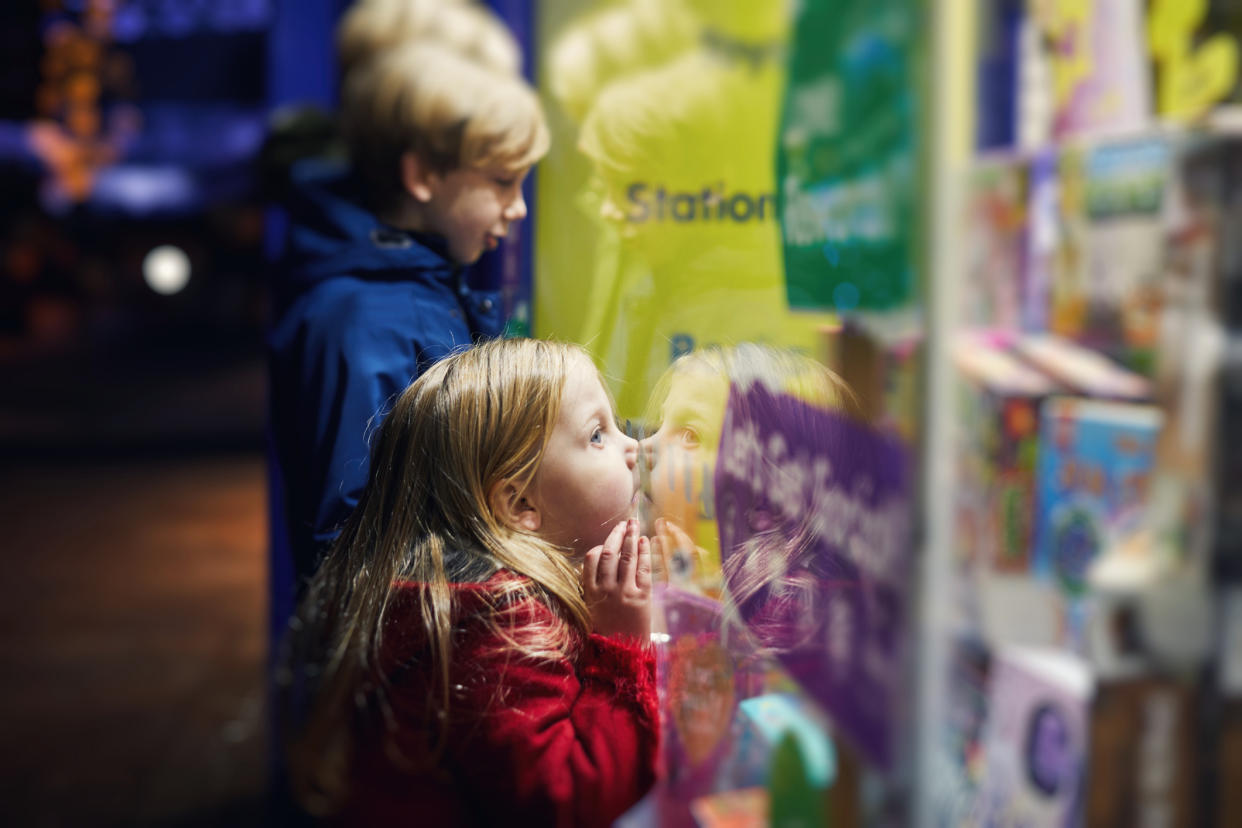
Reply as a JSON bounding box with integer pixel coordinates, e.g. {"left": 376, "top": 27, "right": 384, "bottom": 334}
{"left": 528, "top": 356, "right": 638, "bottom": 557}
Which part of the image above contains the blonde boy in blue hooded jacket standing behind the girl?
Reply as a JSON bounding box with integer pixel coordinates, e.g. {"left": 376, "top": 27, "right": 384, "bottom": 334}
{"left": 270, "top": 43, "right": 548, "bottom": 587}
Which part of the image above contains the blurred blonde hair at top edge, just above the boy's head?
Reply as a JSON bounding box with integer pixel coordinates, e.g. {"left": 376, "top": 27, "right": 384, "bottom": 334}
{"left": 337, "top": 0, "right": 522, "bottom": 78}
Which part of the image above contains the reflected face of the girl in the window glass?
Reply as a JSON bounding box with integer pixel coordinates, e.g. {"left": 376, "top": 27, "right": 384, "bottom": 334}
{"left": 642, "top": 371, "right": 729, "bottom": 528}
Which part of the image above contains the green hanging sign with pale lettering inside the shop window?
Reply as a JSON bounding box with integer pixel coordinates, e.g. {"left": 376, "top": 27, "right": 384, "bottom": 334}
{"left": 776, "top": 0, "right": 922, "bottom": 313}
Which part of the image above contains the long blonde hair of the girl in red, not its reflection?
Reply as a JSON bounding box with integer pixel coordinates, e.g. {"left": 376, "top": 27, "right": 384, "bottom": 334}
{"left": 287, "top": 339, "right": 590, "bottom": 813}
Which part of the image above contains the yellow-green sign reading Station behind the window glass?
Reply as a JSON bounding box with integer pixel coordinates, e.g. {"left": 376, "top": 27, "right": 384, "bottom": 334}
{"left": 534, "top": 0, "right": 832, "bottom": 420}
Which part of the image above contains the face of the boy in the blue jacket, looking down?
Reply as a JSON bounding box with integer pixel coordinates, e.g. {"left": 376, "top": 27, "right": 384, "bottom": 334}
{"left": 426, "top": 168, "right": 530, "bottom": 264}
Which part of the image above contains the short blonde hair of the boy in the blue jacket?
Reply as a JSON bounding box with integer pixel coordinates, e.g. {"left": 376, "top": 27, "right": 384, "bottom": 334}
{"left": 342, "top": 43, "right": 549, "bottom": 209}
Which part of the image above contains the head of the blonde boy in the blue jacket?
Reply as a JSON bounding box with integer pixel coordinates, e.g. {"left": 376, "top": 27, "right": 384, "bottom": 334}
{"left": 343, "top": 43, "right": 548, "bottom": 264}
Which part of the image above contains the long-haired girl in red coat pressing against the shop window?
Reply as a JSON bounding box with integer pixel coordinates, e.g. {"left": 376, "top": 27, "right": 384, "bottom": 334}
{"left": 289, "top": 340, "right": 658, "bottom": 826}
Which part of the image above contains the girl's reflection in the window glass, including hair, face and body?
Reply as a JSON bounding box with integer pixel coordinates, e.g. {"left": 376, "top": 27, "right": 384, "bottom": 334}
{"left": 642, "top": 344, "right": 856, "bottom": 826}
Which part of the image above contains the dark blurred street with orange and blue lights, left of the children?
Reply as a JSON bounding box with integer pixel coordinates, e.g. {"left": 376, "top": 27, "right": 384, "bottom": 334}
{"left": 0, "top": 0, "right": 276, "bottom": 824}
